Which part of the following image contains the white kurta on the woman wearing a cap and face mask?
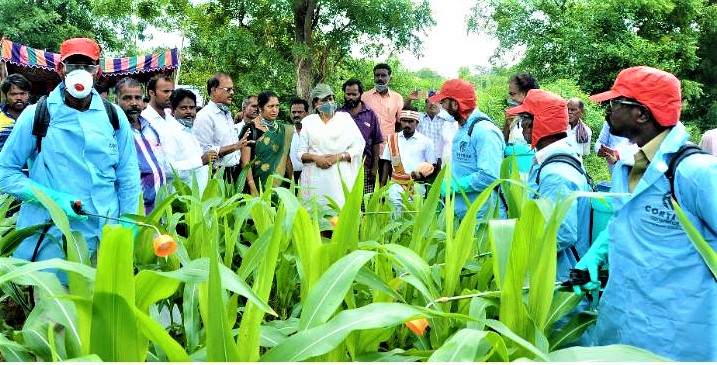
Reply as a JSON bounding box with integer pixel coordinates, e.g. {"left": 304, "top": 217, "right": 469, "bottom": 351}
{"left": 297, "top": 112, "right": 366, "bottom": 207}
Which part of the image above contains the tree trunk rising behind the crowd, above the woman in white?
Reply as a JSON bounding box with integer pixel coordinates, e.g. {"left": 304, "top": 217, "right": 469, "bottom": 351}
{"left": 291, "top": 0, "right": 318, "bottom": 100}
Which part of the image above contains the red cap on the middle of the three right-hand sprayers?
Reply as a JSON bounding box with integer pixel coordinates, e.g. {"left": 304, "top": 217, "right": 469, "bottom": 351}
{"left": 506, "top": 89, "right": 569, "bottom": 147}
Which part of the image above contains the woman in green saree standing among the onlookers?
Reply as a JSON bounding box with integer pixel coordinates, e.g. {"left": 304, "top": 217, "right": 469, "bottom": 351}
{"left": 241, "top": 91, "right": 294, "bottom": 196}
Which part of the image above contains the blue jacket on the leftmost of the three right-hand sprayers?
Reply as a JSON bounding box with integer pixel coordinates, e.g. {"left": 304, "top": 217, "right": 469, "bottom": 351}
{"left": 451, "top": 109, "right": 506, "bottom": 220}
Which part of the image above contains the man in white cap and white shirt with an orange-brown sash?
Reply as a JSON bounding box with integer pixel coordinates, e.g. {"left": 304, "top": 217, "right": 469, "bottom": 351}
{"left": 381, "top": 110, "right": 436, "bottom": 211}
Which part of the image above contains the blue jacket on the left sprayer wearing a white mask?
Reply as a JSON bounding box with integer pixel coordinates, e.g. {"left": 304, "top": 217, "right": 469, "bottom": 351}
{"left": 0, "top": 83, "right": 140, "bottom": 270}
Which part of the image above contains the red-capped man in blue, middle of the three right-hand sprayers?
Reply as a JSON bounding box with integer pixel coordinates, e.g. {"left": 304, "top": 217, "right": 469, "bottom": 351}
{"left": 507, "top": 89, "right": 591, "bottom": 281}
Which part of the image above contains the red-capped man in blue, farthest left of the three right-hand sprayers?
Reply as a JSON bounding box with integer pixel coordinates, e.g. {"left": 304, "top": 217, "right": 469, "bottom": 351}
{"left": 428, "top": 79, "right": 506, "bottom": 219}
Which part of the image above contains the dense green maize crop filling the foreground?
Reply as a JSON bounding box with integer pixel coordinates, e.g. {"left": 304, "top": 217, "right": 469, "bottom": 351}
{"left": 0, "top": 160, "right": 672, "bottom": 362}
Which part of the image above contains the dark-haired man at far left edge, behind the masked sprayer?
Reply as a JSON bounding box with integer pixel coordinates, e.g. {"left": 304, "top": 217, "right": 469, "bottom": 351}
{"left": 0, "top": 74, "right": 31, "bottom": 150}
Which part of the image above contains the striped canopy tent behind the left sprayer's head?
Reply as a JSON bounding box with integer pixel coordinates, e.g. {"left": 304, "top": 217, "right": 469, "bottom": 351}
{"left": 0, "top": 38, "right": 179, "bottom": 94}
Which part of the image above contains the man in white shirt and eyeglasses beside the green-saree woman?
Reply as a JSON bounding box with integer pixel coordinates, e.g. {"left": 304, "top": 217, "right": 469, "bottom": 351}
{"left": 192, "top": 73, "right": 248, "bottom": 182}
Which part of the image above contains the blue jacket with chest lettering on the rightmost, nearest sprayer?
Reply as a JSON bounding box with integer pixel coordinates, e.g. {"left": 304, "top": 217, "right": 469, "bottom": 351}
{"left": 593, "top": 123, "right": 717, "bottom": 361}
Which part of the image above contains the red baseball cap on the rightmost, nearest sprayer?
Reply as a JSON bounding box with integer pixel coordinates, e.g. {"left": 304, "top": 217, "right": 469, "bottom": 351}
{"left": 590, "top": 66, "right": 682, "bottom": 127}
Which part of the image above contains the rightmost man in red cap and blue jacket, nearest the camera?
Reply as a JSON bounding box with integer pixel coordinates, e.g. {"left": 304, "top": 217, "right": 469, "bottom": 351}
{"left": 575, "top": 66, "right": 717, "bottom": 361}
